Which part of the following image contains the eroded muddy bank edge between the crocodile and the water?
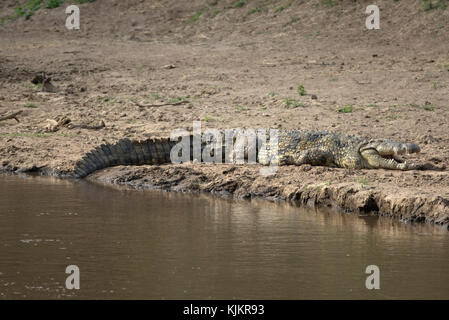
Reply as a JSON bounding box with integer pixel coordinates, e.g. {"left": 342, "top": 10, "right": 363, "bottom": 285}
{"left": 85, "top": 164, "right": 449, "bottom": 228}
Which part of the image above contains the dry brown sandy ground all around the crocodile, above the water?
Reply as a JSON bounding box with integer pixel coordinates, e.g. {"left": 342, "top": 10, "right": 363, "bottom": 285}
{"left": 0, "top": 0, "right": 449, "bottom": 225}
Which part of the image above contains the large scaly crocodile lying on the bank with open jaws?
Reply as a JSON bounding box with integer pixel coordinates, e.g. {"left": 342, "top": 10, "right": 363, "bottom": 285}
{"left": 74, "top": 130, "right": 420, "bottom": 178}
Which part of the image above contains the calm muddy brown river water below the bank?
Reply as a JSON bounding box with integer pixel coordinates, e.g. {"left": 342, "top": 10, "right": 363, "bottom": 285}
{"left": 0, "top": 175, "right": 449, "bottom": 299}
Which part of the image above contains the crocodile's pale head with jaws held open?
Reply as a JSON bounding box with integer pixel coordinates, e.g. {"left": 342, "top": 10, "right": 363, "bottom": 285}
{"left": 359, "top": 140, "right": 421, "bottom": 170}
